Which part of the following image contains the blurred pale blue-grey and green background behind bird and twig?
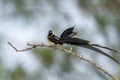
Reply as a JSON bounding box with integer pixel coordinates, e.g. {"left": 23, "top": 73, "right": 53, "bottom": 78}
{"left": 0, "top": 0, "right": 120, "bottom": 80}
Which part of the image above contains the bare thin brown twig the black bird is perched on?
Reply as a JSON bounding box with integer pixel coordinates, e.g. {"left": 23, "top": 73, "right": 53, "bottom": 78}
{"left": 8, "top": 42, "right": 117, "bottom": 80}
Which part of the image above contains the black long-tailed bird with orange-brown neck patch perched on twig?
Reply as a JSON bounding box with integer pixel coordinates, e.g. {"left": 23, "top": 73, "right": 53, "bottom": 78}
{"left": 47, "top": 27, "right": 120, "bottom": 64}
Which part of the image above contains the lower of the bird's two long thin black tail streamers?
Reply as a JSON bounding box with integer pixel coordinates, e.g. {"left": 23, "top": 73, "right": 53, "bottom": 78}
{"left": 79, "top": 45, "right": 119, "bottom": 64}
